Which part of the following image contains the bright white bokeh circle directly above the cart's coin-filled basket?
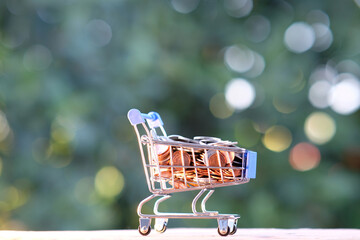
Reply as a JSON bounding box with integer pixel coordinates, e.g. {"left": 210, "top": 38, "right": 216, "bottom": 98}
{"left": 225, "top": 78, "right": 256, "bottom": 110}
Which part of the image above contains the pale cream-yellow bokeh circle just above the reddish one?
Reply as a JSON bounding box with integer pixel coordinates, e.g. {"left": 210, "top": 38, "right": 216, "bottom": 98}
{"left": 304, "top": 112, "right": 336, "bottom": 144}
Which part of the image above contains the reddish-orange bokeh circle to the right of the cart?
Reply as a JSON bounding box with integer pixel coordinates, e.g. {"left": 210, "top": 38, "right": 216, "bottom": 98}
{"left": 289, "top": 142, "right": 321, "bottom": 171}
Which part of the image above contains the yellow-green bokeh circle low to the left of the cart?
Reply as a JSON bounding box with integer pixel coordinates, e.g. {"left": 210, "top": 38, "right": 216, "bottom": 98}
{"left": 95, "top": 166, "right": 124, "bottom": 198}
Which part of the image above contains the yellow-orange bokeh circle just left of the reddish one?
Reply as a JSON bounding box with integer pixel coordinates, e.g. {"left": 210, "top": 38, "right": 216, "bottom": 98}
{"left": 262, "top": 125, "right": 292, "bottom": 152}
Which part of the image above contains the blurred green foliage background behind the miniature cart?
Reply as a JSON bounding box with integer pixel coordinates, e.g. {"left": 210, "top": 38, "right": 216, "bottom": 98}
{"left": 0, "top": 0, "right": 360, "bottom": 230}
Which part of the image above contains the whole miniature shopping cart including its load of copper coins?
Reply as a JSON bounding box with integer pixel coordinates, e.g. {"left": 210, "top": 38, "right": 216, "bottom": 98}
{"left": 128, "top": 109, "right": 257, "bottom": 236}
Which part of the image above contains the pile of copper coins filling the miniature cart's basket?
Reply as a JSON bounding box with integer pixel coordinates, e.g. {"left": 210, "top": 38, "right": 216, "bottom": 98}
{"left": 153, "top": 135, "right": 243, "bottom": 189}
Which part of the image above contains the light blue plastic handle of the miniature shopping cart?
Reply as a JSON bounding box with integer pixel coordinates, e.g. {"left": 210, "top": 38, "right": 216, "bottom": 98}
{"left": 128, "top": 108, "right": 164, "bottom": 128}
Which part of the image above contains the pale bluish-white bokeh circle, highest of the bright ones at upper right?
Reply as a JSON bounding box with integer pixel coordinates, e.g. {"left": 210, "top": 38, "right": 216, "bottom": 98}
{"left": 284, "top": 22, "right": 315, "bottom": 53}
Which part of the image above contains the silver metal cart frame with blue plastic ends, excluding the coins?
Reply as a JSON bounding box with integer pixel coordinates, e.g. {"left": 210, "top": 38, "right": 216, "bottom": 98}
{"left": 128, "top": 109, "right": 257, "bottom": 236}
